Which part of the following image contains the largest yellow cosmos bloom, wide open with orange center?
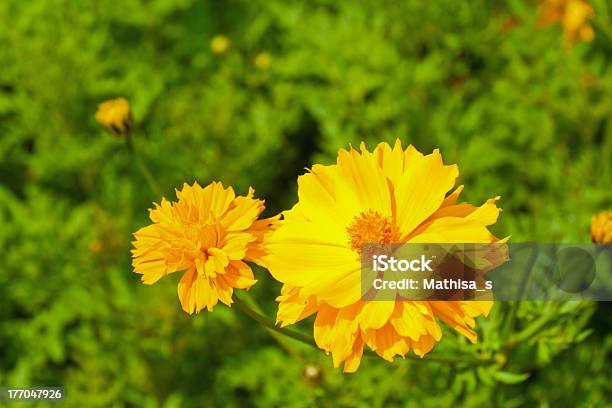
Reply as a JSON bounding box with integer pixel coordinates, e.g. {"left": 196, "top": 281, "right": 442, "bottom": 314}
{"left": 262, "top": 140, "right": 501, "bottom": 372}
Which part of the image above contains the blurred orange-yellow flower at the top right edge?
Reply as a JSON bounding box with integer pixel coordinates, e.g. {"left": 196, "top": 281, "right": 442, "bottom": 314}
{"left": 540, "top": 0, "right": 595, "bottom": 48}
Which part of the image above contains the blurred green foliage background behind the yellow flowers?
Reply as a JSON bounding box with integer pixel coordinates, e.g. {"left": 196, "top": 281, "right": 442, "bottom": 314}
{"left": 0, "top": 0, "right": 612, "bottom": 408}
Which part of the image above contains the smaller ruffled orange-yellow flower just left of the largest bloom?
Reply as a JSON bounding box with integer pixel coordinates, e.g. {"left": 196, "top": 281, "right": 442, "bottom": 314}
{"left": 132, "top": 182, "right": 272, "bottom": 314}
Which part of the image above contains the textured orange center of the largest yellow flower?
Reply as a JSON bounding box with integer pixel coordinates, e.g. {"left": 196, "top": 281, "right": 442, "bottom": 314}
{"left": 346, "top": 210, "right": 399, "bottom": 252}
